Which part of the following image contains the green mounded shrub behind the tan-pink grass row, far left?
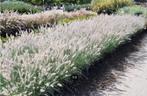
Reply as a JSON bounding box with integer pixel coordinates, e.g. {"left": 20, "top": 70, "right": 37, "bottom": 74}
{"left": 0, "top": 1, "right": 42, "bottom": 13}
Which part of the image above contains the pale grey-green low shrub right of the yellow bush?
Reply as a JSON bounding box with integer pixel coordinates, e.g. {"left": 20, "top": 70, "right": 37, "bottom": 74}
{"left": 117, "top": 5, "right": 147, "bottom": 16}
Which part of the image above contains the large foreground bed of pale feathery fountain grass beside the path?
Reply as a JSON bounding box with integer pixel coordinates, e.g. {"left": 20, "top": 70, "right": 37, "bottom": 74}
{"left": 0, "top": 15, "right": 145, "bottom": 96}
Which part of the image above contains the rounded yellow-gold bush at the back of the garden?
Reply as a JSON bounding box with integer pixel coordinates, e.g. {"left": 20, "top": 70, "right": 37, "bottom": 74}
{"left": 91, "top": 0, "right": 132, "bottom": 14}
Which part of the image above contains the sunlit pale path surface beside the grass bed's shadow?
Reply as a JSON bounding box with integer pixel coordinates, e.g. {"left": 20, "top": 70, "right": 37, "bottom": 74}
{"left": 104, "top": 37, "right": 147, "bottom": 96}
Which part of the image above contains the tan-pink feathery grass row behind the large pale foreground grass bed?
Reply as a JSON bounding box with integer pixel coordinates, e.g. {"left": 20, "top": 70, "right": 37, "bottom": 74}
{"left": 0, "top": 10, "right": 95, "bottom": 37}
